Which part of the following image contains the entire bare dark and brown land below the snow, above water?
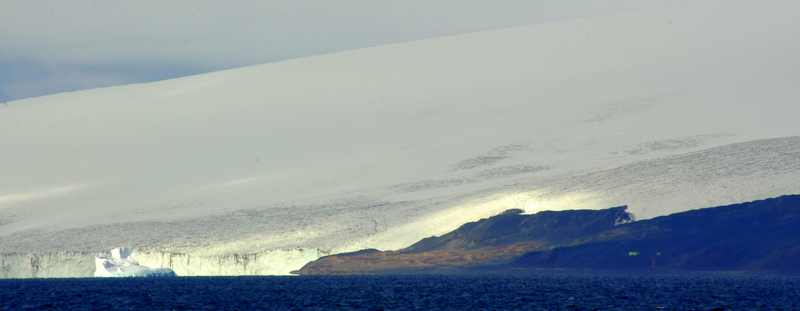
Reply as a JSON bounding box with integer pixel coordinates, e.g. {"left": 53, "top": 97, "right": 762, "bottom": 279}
{"left": 296, "top": 195, "right": 800, "bottom": 274}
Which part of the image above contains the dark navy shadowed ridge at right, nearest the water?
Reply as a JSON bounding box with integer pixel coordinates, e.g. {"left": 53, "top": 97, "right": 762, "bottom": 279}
{"left": 511, "top": 195, "right": 800, "bottom": 272}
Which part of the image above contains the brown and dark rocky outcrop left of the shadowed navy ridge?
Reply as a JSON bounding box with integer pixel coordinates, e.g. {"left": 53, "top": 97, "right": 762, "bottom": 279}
{"left": 293, "top": 206, "right": 632, "bottom": 274}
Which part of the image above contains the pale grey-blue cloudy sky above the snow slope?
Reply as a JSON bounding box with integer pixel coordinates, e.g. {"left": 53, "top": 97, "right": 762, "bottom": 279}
{"left": 0, "top": 0, "right": 700, "bottom": 102}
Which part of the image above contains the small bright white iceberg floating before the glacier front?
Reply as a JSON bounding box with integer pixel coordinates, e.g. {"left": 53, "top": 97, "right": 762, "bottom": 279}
{"left": 94, "top": 246, "right": 177, "bottom": 277}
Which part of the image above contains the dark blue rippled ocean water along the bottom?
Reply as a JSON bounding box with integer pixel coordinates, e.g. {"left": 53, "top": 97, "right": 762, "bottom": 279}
{"left": 0, "top": 275, "right": 800, "bottom": 310}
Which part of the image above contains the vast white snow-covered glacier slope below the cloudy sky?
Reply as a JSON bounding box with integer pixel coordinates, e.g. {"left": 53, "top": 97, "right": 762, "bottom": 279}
{"left": 0, "top": 1, "right": 800, "bottom": 275}
